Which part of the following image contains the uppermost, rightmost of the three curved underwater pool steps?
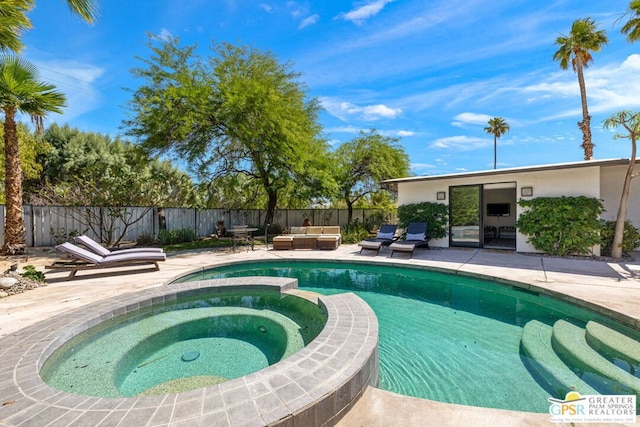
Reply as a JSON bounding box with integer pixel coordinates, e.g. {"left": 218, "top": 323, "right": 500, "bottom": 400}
{"left": 585, "top": 320, "right": 640, "bottom": 366}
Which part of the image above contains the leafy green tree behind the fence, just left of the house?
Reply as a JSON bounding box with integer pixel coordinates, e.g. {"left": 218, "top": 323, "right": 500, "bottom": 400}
{"left": 334, "top": 130, "right": 409, "bottom": 222}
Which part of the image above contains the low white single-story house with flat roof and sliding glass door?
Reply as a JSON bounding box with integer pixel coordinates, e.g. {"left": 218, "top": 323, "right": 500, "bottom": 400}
{"left": 383, "top": 159, "right": 640, "bottom": 255}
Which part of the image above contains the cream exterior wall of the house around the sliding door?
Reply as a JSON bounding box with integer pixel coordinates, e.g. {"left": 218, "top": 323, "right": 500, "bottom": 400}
{"left": 398, "top": 166, "right": 604, "bottom": 254}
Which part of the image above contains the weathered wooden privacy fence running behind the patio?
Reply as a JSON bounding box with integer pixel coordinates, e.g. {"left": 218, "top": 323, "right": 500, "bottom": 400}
{"left": 0, "top": 205, "right": 394, "bottom": 247}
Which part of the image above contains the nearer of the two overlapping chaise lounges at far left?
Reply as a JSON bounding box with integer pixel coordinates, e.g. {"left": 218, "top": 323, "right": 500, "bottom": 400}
{"left": 45, "top": 242, "right": 167, "bottom": 280}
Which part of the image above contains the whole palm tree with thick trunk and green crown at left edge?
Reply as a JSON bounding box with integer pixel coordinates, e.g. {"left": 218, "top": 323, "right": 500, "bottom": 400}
{"left": 0, "top": 56, "right": 65, "bottom": 254}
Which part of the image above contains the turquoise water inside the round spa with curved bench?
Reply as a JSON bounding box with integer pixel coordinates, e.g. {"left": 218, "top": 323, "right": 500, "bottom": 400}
{"left": 41, "top": 291, "right": 326, "bottom": 397}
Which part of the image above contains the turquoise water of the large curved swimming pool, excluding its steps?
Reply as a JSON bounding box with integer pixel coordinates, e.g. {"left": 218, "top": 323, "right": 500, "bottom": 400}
{"left": 174, "top": 260, "right": 639, "bottom": 412}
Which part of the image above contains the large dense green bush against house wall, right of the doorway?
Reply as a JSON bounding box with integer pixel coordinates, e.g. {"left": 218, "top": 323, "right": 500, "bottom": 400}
{"left": 516, "top": 196, "right": 603, "bottom": 256}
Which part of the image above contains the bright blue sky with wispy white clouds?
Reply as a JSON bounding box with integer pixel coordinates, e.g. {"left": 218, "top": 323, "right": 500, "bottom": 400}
{"left": 18, "top": 0, "right": 640, "bottom": 175}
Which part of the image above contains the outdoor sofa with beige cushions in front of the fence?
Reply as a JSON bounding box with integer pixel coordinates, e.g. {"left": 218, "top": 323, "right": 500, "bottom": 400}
{"left": 273, "top": 225, "right": 342, "bottom": 250}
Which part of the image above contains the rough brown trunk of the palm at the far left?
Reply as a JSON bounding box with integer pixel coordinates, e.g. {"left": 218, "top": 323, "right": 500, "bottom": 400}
{"left": 2, "top": 109, "right": 25, "bottom": 255}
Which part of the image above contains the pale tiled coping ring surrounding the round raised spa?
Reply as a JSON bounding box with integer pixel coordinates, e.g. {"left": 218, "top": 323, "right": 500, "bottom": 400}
{"left": 0, "top": 277, "right": 378, "bottom": 426}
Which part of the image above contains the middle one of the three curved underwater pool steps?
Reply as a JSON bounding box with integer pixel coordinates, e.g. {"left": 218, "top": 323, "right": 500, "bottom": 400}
{"left": 551, "top": 320, "right": 640, "bottom": 394}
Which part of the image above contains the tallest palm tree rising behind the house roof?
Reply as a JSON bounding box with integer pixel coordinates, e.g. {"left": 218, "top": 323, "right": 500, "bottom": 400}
{"left": 553, "top": 18, "right": 609, "bottom": 160}
